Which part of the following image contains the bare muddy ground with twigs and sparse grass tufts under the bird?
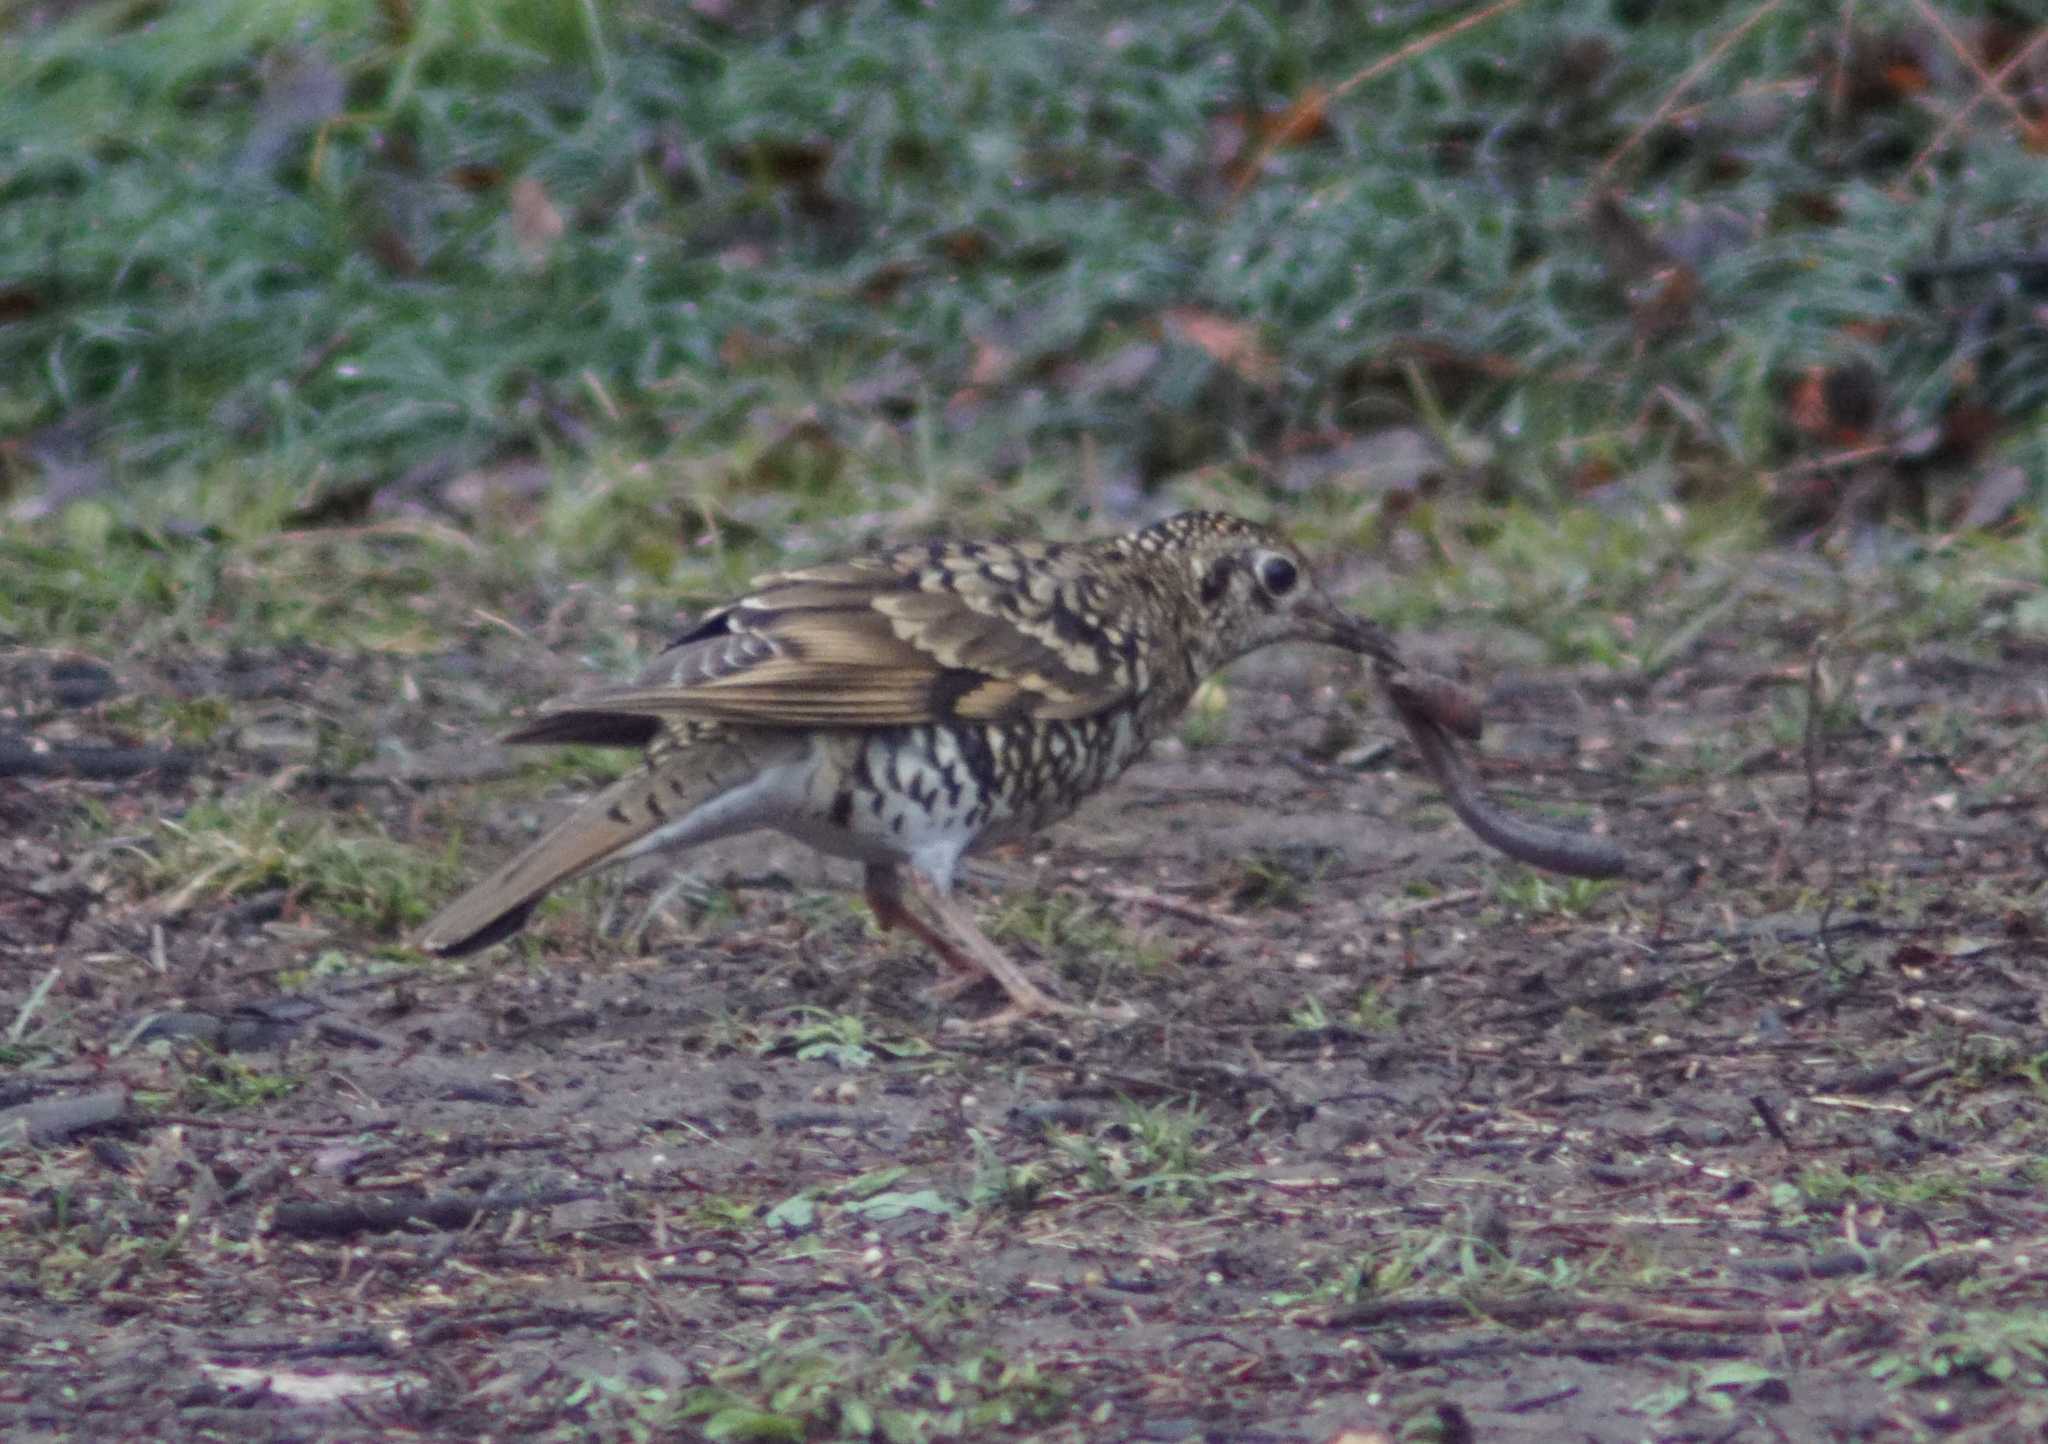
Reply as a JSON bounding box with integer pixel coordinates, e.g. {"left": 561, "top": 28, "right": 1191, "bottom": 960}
{"left": 0, "top": 569, "right": 2048, "bottom": 1444}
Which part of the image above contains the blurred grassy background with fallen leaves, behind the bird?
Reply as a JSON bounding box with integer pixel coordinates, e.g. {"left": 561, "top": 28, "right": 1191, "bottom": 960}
{"left": 0, "top": 0, "right": 2048, "bottom": 664}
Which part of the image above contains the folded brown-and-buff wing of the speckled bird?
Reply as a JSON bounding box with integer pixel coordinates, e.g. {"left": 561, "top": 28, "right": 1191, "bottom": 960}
{"left": 512, "top": 545, "right": 1149, "bottom": 741}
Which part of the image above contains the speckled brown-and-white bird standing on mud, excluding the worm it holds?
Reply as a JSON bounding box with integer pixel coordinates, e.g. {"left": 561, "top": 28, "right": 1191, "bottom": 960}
{"left": 416, "top": 512, "right": 1399, "bottom": 1028}
